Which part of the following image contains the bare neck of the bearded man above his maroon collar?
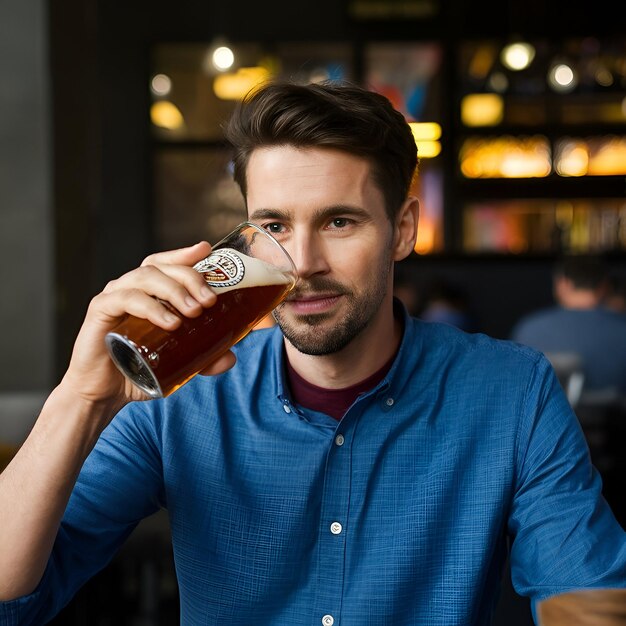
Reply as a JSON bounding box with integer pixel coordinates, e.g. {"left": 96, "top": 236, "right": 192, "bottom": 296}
{"left": 285, "top": 300, "right": 403, "bottom": 389}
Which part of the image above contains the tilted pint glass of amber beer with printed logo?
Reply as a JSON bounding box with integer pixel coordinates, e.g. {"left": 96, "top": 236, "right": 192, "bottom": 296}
{"left": 105, "top": 222, "right": 297, "bottom": 398}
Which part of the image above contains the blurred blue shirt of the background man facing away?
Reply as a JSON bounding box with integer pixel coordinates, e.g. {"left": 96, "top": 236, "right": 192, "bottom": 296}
{"left": 511, "top": 306, "right": 626, "bottom": 395}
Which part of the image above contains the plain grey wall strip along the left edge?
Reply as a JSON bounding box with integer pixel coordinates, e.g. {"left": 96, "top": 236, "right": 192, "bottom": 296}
{"left": 0, "top": 0, "right": 53, "bottom": 390}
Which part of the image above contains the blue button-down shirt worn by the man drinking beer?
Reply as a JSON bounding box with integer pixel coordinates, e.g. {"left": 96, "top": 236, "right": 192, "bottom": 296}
{"left": 0, "top": 308, "right": 626, "bottom": 626}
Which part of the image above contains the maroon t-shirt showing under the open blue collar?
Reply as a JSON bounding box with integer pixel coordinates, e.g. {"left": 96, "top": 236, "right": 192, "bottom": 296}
{"left": 287, "top": 354, "right": 396, "bottom": 420}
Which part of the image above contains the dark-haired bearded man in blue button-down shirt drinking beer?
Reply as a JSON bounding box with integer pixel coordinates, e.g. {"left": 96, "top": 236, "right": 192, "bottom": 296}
{"left": 0, "top": 84, "right": 626, "bottom": 626}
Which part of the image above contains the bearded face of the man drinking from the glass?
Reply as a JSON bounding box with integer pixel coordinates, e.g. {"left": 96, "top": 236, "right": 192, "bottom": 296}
{"left": 247, "top": 146, "right": 394, "bottom": 355}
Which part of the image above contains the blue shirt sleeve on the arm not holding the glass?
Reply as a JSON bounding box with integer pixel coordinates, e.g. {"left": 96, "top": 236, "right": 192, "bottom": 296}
{"left": 509, "top": 358, "right": 626, "bottom": 602}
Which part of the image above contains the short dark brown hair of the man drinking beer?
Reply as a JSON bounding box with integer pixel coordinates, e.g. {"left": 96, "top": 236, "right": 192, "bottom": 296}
{"left": 225, "top": 81, "right": 417, "bottom": 221}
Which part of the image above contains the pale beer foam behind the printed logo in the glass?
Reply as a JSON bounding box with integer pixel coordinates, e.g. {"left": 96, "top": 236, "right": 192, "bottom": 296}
{"left": 194, "top": 248, "right": 293, "bottom": 294}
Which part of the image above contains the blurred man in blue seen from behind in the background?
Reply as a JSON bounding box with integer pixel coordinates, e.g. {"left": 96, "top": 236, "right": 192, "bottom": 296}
{"left": 512, "top": 255, "right": 626, "bottom": 396}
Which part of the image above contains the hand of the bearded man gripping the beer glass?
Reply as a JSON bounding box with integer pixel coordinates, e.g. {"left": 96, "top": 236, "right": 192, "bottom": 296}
{"left": 62, "top": 241, "right": 235, "bottom": 411}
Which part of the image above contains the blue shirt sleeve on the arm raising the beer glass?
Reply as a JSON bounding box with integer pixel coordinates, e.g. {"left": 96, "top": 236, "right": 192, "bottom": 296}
{"left": 0, "top": 401, "right": 164, "bottom": 626}
